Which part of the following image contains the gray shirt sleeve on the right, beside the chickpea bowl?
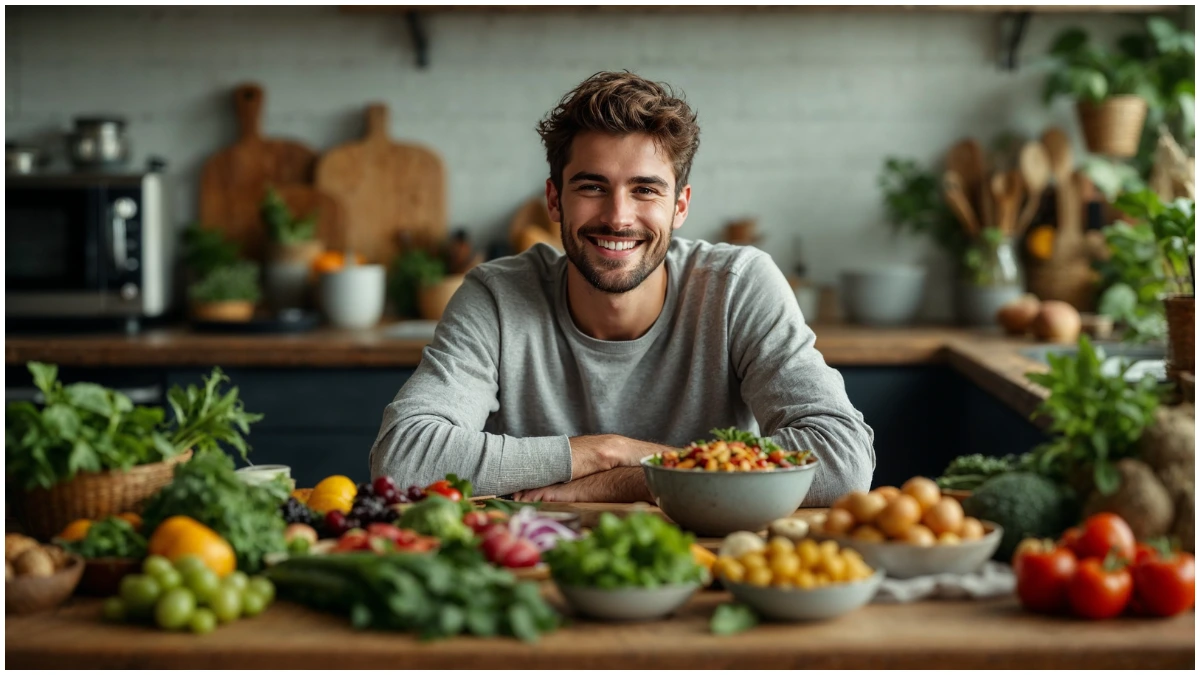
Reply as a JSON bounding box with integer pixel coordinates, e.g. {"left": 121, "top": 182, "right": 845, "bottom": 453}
{"left": 730, "top": 253, "right": 875, "bottom": 506}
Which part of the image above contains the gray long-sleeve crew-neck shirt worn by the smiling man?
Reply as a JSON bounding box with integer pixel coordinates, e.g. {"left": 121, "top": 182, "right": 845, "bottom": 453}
{"left": 371, "top": 238, "right": 875, "bottom": 506}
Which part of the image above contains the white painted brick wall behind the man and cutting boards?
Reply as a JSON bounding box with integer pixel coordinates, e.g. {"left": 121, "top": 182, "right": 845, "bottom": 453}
{"left": 5, "top": 7, "right": 1161, "bottom": 318}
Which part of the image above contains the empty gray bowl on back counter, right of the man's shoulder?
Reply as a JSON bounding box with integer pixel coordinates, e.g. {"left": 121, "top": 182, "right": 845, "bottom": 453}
{"left": 841, "top": 265, "right": 925, "bottom": 325}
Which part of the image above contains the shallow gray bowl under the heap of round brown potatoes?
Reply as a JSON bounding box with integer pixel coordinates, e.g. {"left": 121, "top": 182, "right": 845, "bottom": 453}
{"left": 810, "top": 520, "right": 1004, "bottom": 579}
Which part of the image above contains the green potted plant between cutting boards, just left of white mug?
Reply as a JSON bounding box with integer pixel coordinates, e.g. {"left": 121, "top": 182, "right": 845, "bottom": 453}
{"left": 259, "top": 186, "right": 324, "bottom": 310}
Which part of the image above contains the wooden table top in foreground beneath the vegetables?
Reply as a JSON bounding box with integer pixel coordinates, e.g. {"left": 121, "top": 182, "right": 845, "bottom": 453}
{"left": 5, "top": 503, "right": 1195, "bottom": 669}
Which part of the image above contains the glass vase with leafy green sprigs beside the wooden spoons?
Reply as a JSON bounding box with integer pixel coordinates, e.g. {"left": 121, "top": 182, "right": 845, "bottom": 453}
{"left": 880, "top": 157, "right": 1024, "bottom": 325}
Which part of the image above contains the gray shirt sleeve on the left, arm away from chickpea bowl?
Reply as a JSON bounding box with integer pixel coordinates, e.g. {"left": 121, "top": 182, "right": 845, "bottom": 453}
{"left": 370, "top": 270, "right": 571, "bottom": 495}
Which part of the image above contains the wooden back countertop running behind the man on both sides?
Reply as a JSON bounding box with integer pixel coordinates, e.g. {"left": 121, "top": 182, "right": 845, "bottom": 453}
{"left": 5, "top": 325, "right": 1045, "bottom": 416}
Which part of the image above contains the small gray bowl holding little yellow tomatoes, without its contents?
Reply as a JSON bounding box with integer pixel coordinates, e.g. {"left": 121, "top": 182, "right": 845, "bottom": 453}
{"left": 721, "top": 569, "right": 883, "bottom": 621}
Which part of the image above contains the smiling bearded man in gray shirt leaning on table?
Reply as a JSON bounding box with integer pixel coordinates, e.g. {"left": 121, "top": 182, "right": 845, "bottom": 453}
{"left": 371, "top": 72, "right": 875, "bottom": 506}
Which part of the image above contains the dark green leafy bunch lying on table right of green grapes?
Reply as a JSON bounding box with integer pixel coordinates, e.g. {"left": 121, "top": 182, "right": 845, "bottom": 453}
{"left": 266, "top": 546, "right": 560, "bottom": 643}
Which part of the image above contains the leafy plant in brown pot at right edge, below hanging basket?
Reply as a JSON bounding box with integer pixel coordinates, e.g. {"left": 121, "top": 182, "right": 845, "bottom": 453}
{"left": 1114, "top": 190, "right": 1196, "bottom": 380}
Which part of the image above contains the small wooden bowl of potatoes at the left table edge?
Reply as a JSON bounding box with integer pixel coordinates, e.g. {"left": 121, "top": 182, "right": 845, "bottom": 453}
{"left": 4, "top": 533, "right": 84, "bottom": 614}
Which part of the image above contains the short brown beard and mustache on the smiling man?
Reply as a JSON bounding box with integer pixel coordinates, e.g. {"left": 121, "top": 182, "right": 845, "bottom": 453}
{"left": 562, "top": 215, "right": 674, "bottom": 290}
